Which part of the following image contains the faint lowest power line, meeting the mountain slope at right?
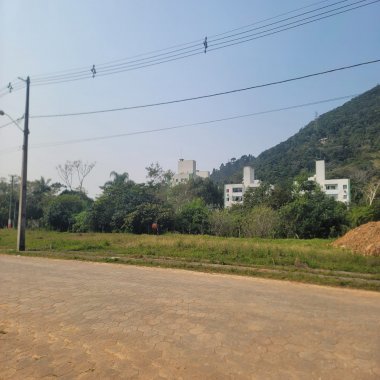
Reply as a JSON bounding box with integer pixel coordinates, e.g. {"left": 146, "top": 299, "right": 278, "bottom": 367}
{"left": 0, "top": 94, "right": 357, "bottom": 153}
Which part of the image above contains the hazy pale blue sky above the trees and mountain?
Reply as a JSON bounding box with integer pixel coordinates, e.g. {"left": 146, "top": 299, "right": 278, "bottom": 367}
{"left": 0, "top": 0, "right": 380, "bottom": 196}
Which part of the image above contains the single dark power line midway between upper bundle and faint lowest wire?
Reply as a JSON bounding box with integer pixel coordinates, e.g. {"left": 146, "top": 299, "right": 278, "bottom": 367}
{"left": 30, "top": 59, "right": 380, "bottom": 119}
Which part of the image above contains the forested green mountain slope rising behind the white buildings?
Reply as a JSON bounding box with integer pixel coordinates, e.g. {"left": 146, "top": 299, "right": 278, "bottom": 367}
{"left": 211, "top": 85, "right": 380, "bottom": 184}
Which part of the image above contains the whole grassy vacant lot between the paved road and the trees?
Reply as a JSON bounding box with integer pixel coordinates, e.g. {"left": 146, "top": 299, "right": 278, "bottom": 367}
{"left": 0, "top": 230, "right": 380, "bottom": 291}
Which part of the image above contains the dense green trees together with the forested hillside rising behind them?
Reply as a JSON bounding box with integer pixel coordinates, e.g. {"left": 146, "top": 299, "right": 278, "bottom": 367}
{"left": 0, "top": 86, "right": 380, "bottom": 238}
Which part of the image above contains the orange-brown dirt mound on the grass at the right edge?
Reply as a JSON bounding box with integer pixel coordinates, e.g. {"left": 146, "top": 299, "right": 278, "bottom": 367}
{"left": 332, "top": 222, "right": 380, "bottom": 256}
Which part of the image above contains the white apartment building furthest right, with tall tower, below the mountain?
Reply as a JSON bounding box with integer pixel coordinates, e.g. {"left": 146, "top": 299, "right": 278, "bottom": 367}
{"left": 308, "top": 160, "right": 351, "bottom": 204}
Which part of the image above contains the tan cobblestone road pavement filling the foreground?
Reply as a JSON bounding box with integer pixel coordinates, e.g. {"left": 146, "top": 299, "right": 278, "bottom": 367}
{"left": 0, "top": 255, "right": 380, "bottom": 380}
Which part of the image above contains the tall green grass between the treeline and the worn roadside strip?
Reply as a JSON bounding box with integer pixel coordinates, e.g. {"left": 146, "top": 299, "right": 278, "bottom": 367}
{"left": 0, "top": 230, "right": 380, "bottom": 274}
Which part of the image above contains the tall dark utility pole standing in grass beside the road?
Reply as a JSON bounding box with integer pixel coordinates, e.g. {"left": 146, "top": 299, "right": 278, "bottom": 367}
{"left": 17, "top": 77, "right": 30, "bottom": 251}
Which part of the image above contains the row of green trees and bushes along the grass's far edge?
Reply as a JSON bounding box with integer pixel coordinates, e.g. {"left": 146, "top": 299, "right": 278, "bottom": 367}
{"left": 0, "top": 164, "right": 380, "bottom": 238}
